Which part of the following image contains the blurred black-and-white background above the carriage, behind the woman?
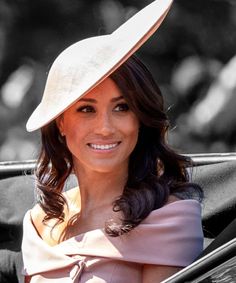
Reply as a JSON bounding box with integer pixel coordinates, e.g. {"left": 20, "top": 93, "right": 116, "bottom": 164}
{"left": 0, "top": 0, "right": 236, "bottom": 161}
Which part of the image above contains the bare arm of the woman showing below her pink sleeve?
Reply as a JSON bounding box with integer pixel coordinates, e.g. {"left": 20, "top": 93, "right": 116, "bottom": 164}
{"left": 142, "top": 264, "right": 181, "bottom": 283}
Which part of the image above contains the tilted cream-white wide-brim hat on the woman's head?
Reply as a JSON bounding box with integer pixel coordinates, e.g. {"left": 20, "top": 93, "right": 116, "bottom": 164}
{"left": 26, "top": 0, "right": 173, "bottom": 132}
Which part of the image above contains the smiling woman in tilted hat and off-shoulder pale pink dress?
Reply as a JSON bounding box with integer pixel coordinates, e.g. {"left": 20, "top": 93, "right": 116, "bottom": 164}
{"left": 22, "top": 1, "right": 202, "bottom": 283}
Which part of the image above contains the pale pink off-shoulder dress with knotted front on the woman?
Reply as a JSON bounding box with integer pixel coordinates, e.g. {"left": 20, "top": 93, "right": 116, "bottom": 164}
{"left": 22, "top": 200, "right": 203, "bottom": 283}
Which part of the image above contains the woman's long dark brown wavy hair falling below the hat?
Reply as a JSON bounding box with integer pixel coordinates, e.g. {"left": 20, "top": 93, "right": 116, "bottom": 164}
{"left": 36, "top": 55, "right": 203, "bottom": 236}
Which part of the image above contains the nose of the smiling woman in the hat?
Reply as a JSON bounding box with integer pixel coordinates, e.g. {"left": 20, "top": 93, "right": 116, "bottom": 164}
{"left": 95, "top": 112, "right": 115, "bottom": 136}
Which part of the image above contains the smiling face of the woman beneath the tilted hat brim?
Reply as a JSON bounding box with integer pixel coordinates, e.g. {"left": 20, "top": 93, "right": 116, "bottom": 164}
{"left": 57, "top": 78, "right": 139, "bottom": 173}
